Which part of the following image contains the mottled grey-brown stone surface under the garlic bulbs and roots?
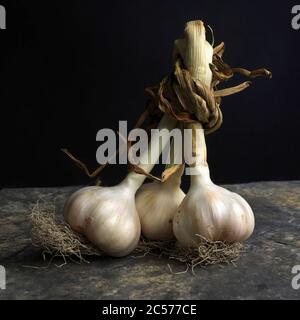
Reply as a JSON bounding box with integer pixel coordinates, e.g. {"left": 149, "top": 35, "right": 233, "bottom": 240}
{"left": 0, "top": 181, "right": 300, "bottom": 299}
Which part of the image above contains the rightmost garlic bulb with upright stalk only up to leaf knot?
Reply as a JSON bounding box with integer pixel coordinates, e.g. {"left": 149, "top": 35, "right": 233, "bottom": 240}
{"left": 173, "top": 123, "right": 254, "bottom": 247}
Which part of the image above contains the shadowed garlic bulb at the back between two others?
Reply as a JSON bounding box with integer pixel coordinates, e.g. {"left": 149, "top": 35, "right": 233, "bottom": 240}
{"left": 136, "top": 165, "right": 185, "bottom": 240}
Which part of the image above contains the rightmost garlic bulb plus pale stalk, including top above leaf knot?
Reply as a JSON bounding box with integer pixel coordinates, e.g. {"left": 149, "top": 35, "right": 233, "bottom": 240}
{"left": 173, "top": 21, "right": 254, "bottom": 247}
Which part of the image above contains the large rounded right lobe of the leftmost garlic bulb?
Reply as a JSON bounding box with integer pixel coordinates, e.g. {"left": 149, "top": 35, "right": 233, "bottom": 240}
{"left": 85, "top": 184, "right": 141, "bottom": 257}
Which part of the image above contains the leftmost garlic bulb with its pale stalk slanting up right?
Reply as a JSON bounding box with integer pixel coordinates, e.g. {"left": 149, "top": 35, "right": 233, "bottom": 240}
{"left": 64, "top": 115, "right": 176, "bottom": 257}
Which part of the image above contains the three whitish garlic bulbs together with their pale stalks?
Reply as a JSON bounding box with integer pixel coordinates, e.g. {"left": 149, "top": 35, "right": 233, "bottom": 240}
{"left": 64, "top": 21, "right": 254, "bottom": 257}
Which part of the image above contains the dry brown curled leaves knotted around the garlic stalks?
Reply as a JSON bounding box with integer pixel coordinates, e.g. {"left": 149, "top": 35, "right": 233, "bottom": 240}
{"left": 62, "top": 38, "right": 272, "bottom": 182}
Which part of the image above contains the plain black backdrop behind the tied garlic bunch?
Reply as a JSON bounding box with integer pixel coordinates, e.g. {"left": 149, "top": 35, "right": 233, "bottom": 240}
{"left": 0, "top": 0, "right": 300, "bottom": 187}
